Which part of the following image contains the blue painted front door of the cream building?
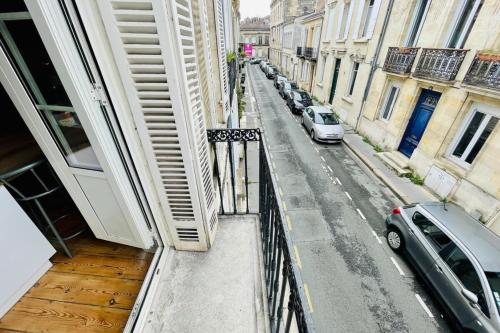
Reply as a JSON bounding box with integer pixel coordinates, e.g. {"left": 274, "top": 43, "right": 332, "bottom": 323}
{"left": 399, "top": 89, "right": 441, "bottom": 157}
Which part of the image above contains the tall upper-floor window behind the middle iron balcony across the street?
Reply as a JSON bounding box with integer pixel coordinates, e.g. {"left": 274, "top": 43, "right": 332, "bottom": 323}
{"left": 446, "top": 0, "right": 482, "bottom": 49}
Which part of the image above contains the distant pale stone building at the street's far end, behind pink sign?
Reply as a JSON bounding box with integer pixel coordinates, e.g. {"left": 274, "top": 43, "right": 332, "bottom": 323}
{"left": 240, "top": 16, "right": 270, "bottom": 58}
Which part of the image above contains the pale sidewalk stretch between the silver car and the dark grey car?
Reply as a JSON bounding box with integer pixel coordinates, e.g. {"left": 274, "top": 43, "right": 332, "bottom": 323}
{"left": 342, "top": 123, "right": 439, "bottom": 204}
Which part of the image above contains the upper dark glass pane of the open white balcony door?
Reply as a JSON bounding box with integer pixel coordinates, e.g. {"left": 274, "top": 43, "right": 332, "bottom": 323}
{"left": 5, "top": 20, "right": 71, "bottom": 106}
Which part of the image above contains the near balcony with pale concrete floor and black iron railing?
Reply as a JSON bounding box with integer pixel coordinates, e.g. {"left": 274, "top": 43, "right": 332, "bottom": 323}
{"left": 143, "top": 129, "right": 314, "bottom": 333}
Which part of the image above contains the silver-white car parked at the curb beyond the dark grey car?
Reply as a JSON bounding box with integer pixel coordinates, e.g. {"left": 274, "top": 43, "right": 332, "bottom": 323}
{"left": 302, "top": 106, "right": 344, "bottom": 142}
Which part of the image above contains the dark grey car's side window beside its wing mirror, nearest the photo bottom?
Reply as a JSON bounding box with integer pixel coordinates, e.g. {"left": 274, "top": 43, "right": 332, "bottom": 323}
{"left": 440, "top": 243, "right": 489, "bottom": 317}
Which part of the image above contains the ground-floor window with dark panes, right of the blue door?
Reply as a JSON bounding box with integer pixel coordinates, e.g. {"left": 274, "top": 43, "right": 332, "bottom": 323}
{"left": 451, "top": 107, "right": 500, "bottom": 164}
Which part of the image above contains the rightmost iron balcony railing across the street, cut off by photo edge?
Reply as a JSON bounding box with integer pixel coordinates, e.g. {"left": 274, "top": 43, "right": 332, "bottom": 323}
{"left": 463, "top": 52, "right": 500, "bottom": 90}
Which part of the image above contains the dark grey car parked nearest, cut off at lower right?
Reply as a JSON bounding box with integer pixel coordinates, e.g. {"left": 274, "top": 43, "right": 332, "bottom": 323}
{"left": 386, "top": 202, "right": 500, "bottom": 332}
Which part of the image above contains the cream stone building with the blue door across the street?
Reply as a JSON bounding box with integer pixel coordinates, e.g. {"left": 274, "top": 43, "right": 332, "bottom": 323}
{"left": 313, "top": 0, "right": 500, "bottom": 233}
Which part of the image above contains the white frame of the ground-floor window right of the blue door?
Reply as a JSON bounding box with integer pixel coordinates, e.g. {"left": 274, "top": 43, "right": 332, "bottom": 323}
{"left": 446, "top": 103, "right": 500, "bottom": 169}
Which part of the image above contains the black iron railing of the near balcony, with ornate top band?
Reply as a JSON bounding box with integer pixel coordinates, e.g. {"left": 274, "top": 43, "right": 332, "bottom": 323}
{"left": 208, "top": 128, "right": 314, "bottom": 333}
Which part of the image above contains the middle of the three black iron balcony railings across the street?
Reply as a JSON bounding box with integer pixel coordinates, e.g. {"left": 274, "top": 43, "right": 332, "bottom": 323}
{"left": 413, "top": 49, "right": 468, "bottom": 82}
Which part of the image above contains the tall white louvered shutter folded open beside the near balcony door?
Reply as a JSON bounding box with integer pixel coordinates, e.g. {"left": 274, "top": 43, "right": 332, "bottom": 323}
{"left": 97, "top": 0, "right": 217, "bottom": 250}
